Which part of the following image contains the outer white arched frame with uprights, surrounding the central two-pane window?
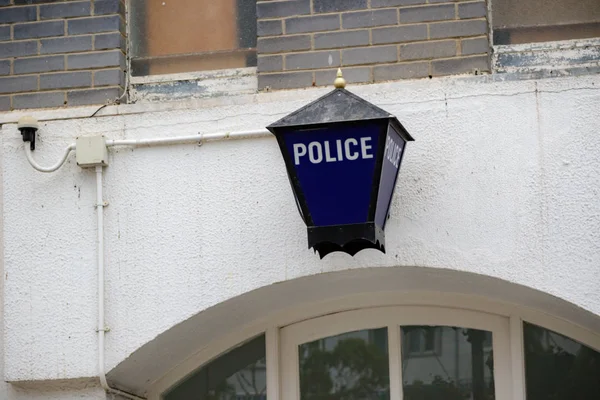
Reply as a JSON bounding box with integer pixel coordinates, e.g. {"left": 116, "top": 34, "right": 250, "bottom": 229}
{"left": 147, "top": 291, "right": 600, "bottom": 400}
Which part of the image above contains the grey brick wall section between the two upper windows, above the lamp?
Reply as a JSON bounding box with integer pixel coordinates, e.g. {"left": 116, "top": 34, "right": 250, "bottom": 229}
{"left": 257, "top": 0, "right": 489, "bottom": 90}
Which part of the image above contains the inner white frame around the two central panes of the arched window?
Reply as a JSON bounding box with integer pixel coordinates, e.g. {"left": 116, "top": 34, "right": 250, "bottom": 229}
{"left": 280, "top": 306, "right": 512, "bottom": 400}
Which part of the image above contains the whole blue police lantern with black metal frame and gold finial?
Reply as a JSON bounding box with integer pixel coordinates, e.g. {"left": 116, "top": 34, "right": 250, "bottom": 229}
{"left": 267, "top": 70, "right": 414, "bottom": 258}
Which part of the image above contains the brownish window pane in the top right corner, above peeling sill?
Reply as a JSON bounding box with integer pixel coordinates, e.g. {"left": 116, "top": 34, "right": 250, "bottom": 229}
{"left": 492, "top": 0, "right": 600, "bottom": 44}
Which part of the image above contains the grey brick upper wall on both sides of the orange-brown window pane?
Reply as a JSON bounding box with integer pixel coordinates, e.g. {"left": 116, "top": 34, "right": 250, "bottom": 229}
{"left": 0, "top": 0, "right": 489, "bottom": 111}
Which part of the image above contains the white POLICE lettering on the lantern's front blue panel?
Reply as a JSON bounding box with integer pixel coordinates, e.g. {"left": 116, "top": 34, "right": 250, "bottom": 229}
{"left": 293, "top": 137, "right": 373, "bottom": 165}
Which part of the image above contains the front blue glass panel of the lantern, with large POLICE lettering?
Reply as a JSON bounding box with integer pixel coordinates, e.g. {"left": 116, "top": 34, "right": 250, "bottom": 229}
{"left": 283, "top": 122, "right": 382, "bottom": 226}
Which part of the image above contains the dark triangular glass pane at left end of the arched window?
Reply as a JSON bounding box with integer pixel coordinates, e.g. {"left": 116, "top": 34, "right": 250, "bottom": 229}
{"left": 163, "top": 335, "right": 267, "bottom": 400}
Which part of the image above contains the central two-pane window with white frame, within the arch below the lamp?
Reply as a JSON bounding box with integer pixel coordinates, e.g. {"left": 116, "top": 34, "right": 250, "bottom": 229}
{"left": 281, "top": 307, "right": 511, "bottom": 400}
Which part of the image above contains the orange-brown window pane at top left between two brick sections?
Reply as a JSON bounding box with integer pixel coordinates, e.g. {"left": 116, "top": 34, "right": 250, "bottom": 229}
{"left": 130, "top": 0, "right": 256, "bottom": 75}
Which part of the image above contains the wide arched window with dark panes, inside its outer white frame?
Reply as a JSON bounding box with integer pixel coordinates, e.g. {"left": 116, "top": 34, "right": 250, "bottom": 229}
{"left": 158, "top": 306, "right": 600, "bottom": 400}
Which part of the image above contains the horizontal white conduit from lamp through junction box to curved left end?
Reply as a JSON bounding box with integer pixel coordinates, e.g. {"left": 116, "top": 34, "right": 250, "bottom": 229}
{"left": 24, "top": 129, "right": 270, "bottom": 172}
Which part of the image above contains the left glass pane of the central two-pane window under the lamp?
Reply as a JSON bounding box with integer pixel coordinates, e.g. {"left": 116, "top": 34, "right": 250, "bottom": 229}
{"left": 298, "top": 328, "right": 390, "bottom": 400}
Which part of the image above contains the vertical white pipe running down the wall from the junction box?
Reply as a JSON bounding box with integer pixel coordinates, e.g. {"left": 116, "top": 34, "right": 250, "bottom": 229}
{"left": 96, "top": 165, "right": 144, "bottom": 400}
